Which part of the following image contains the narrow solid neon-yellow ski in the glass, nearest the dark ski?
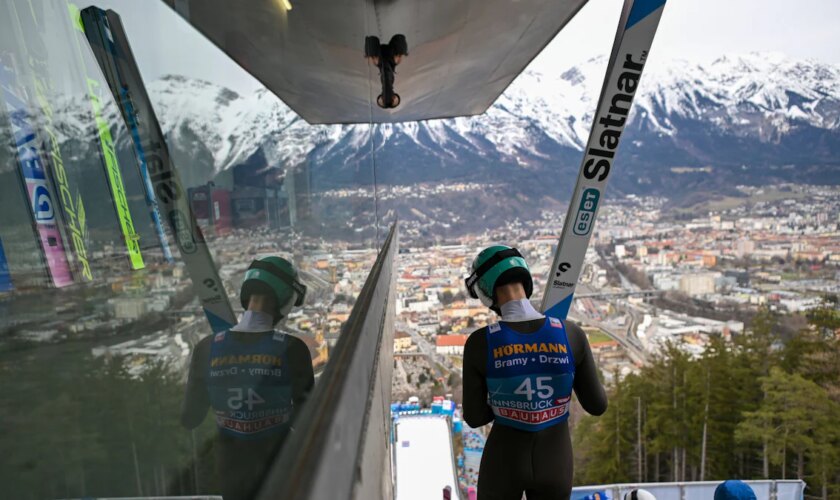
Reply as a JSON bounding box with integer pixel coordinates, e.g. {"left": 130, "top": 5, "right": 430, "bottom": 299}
{"left": 68, "top": 4, "right": 146, "bottom": 270}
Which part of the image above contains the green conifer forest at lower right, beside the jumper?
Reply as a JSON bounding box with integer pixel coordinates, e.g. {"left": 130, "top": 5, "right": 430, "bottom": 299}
{"left": 573, "top": 301, "right": 840, "bottom": 499}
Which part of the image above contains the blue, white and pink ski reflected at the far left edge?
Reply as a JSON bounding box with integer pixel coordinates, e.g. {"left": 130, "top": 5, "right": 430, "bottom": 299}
{"left": 0, "top": 56, "right": 73, "bottom": 287}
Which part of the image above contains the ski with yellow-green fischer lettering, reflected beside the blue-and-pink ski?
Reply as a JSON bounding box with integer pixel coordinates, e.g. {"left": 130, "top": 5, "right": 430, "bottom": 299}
{"left": 6, "top": 0, "right": 93, "bottom": 282}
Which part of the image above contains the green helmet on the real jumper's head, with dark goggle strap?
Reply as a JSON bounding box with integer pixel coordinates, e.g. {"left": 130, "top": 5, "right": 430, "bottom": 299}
{"left": 464, "top": 245, "right": 534, "bottom": 313}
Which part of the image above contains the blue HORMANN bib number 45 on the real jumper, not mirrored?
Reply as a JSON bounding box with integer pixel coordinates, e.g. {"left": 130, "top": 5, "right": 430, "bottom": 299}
{"left": 487, "top": 317, "right": 575, "bottom": 431}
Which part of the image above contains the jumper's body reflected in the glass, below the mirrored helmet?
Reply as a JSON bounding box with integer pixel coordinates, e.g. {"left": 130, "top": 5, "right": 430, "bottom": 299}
{"left": 181, "top": 330, "right": 315, "bottom": 500}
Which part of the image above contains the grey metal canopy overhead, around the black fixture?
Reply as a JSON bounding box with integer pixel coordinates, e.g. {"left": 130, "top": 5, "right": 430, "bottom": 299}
{"left": 163, "top": 0, "right": 586, "bottom": 124}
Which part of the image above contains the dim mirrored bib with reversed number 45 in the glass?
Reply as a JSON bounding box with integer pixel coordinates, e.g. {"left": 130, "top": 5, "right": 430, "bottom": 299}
{"left": 207, "top": 332, "right": 293, "bottom": 438}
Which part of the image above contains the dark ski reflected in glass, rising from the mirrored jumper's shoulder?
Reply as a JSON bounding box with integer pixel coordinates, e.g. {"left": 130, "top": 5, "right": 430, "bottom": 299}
{"left": 79, "top": 7, "right": 236, "bottom": 332}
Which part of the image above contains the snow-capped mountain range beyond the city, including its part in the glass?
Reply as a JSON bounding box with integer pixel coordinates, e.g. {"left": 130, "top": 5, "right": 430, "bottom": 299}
{"left": 133, "top": 53, "right": 840, "bottom": 196}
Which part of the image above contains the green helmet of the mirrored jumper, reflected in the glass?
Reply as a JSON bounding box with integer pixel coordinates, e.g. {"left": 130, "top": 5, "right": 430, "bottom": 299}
{"left": 239, "top": 257, "right": 306, "bottom": 321}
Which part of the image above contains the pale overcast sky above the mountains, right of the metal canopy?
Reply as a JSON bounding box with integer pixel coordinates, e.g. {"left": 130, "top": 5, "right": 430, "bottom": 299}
{"left": 533, "top": 0, "right": 840, "bottom": 71}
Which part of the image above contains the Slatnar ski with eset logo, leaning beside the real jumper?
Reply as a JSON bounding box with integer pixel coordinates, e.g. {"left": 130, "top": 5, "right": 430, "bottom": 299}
{"left": 541, "top": 0, "right": 665, "bottom": 318}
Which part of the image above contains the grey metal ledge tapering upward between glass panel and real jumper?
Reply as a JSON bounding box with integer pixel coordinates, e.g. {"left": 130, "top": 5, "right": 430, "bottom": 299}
{"left": 257, "top": 223, "right": 399, "bottom": 500}
